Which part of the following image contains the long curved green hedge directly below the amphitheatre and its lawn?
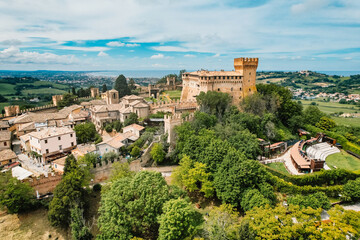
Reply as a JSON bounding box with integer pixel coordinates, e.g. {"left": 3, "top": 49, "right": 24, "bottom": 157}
{"left": 264, "top": 165, "right": 360, "bottom": 186}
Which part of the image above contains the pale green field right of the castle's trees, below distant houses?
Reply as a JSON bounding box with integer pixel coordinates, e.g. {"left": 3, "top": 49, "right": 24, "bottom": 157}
{"left": 301, "top": 100, "right": 360, "bottom": 114}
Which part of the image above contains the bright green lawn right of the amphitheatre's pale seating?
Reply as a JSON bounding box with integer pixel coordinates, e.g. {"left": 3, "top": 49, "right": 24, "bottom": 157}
{"left": 326, "top": 150, "right": 360, "bottom": 171}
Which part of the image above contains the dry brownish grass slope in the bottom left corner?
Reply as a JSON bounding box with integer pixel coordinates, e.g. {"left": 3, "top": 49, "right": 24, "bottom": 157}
{"left": 0, "top": 209, "right": 70, "bottom": 240}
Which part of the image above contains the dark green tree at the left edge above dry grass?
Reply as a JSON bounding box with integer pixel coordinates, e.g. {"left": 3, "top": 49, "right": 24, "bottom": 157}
{"left": 0, "top": 171, "right": 35, "bottom": 213}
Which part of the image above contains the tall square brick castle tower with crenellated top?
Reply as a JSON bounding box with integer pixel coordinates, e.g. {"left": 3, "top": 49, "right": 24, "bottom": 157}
{"left": 234, "top": 58, "right": 259, "bottom": 97}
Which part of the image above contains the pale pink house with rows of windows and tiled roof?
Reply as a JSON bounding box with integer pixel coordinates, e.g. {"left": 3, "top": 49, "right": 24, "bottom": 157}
{"left": 29, "top": 127, "right": 77, "bottom": 164}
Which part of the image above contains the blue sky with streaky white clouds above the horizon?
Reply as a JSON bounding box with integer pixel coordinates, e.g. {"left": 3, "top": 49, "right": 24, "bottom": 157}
{"left": 0, "top": 0, "right": 360, "bottom": 71}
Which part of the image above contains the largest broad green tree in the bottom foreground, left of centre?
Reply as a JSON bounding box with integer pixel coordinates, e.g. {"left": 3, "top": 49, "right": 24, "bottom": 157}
{"left": 98, "top": 171, "right": 170, "bottom": 239}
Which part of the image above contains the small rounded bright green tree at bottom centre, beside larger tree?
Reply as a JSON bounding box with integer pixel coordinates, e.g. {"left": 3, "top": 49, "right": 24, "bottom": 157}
{"left": 158, "top": 198, "right": 202, "bottom": 240}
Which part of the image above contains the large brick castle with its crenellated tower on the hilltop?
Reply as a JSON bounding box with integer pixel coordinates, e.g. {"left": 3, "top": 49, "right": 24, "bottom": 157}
{"left": 181, "top": 58, "right": 258, "bottom": 105}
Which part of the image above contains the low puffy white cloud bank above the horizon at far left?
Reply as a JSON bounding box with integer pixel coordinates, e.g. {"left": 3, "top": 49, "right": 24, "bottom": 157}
{"left": 0, "top": 46, "right": 77, "bottom": 64}
